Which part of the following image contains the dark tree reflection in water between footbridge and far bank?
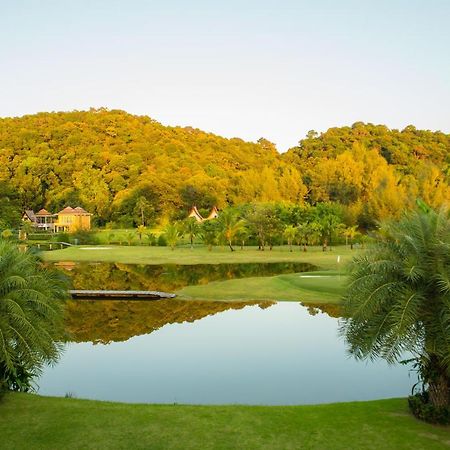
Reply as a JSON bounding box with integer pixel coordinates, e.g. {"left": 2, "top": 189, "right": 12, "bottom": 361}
{"left": 57, "top": 263, "right": 314, "bottom": 291}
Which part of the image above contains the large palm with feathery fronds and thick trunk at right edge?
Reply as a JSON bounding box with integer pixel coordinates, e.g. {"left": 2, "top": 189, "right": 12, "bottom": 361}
{"left": 341, "top": 210, "right": 450, "bottom": 407}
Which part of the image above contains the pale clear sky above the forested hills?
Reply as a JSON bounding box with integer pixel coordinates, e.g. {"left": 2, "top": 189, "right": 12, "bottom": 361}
{"left": 0, "top": 0, "right": 450, "bottom": 151}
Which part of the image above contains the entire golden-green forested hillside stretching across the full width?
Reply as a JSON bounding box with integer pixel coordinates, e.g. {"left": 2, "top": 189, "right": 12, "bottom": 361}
{"left": 0, "top": 109, "right": 450, "bottom": 225}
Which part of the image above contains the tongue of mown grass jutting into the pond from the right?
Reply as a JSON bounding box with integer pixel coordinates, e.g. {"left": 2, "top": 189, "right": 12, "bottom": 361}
{"left": 176, "top": 271, "right": 346, "bottom": 303}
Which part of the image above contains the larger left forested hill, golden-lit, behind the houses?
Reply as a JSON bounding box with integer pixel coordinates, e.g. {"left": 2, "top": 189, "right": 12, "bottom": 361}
{"left": 0, "top": 109, "right": 306, "bottom": 225}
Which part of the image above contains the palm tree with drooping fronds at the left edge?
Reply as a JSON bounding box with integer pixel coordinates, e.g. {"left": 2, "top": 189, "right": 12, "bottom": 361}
{"left": 0, "top": 242, "right": 68, "bottom": 390}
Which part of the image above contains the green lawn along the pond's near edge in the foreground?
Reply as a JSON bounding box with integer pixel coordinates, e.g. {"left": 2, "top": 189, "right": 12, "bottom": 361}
{"left": 0, "top": 393, "right": 450, "bottom": 450}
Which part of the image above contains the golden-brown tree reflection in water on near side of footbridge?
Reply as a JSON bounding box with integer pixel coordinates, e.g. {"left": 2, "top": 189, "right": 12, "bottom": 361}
{"left": 66, "top": 300, "right": 275, "bottom": 344}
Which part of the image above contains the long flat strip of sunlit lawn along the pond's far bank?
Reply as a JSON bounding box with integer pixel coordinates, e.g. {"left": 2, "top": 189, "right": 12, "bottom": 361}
{"left": 43, "top": 245, "right": 357, "bottom": 270}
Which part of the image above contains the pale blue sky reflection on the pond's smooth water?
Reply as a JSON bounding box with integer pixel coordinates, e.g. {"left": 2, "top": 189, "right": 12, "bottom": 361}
{"left": 38, "top": 303, "right": 414, "bottom": 404}
